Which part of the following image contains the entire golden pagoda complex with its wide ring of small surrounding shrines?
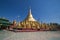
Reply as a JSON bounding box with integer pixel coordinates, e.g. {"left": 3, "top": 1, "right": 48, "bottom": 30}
{"left": 13, "top": 9, "right": 55, "bottom": 31}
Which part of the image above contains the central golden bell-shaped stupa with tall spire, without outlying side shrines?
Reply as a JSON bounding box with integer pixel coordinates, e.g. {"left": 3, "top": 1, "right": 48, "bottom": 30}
{"left": 19, "top": 9, "right": 41, "bottom": 29}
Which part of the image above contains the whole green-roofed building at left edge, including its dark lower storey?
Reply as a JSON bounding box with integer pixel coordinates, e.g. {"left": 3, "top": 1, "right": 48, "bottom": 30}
{"left": 0, "top": 18, "right": 12, "bottom": 29}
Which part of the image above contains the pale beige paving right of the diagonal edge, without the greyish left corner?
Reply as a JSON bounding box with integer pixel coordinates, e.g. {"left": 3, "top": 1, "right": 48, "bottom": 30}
{"left": 4, "top": 32, "right": 60, "bottom": 40}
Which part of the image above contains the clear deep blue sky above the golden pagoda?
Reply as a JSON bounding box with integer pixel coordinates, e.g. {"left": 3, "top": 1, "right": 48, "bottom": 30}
{"left": 0, "top": 0, "right": 60, "bottom": 23}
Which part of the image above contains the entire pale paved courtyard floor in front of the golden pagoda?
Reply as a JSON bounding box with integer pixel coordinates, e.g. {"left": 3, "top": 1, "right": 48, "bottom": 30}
{"left": 0, "top": 30, "right": 60, "bottom": 40}
